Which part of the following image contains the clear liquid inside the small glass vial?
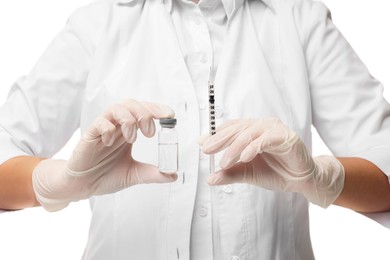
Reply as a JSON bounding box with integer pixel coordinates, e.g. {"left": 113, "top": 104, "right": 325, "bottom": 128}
{"left": 158, "top": 143, "right": 178, "bottom": 173}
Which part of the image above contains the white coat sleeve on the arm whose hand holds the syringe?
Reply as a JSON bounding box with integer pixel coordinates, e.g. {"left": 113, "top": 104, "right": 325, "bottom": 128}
{"left": 303, "top": 2, "right": 390, "bottom": 179}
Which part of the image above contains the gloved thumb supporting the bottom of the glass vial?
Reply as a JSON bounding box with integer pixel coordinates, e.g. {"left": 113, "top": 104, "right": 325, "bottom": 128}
{"left": 129, "top": 161, "right": 177, "bottom": 184}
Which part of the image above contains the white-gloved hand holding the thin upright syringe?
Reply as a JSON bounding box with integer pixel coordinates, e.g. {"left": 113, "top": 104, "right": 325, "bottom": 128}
{"left": 199, "top": 118, "right": 345, "bottom": 207}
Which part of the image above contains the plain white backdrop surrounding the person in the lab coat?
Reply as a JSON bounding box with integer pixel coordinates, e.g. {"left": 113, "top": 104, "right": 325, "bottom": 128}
{"left": 0, "top": 0, "right": 390, "bottom": 260}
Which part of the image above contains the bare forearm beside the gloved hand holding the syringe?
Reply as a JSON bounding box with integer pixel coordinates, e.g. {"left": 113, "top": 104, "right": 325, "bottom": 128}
{"left": 334, "top": 158, "right": 390, "bottom": 212}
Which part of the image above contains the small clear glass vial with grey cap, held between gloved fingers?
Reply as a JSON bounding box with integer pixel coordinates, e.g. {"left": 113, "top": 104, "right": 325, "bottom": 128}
{"left": 158, "top": 118, "right": 179, "bottom": 173}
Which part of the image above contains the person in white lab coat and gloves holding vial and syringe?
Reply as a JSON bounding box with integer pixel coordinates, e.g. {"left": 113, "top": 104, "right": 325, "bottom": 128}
{"left": 0, "top": 0, "right": 390, "bottom": 260}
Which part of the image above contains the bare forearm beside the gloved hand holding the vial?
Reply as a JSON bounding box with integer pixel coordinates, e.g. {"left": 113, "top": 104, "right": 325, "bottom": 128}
{"left": 0, "top": 156, "right": 42, "bottom": 210}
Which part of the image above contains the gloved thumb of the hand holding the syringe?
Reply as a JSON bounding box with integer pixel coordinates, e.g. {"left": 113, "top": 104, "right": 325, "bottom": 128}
{"left": 207, "top": 162, "right": 247, "bottom": 186}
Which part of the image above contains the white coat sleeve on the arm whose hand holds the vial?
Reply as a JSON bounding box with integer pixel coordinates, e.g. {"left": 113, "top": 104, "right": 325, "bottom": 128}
{"left": 0, "top": 8, "right": 93, "bottom": 163}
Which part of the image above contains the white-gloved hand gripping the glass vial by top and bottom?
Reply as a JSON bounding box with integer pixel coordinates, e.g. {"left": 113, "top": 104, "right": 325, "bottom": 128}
{"left": 33, "top": 100, "right": 177, "bottom": 211}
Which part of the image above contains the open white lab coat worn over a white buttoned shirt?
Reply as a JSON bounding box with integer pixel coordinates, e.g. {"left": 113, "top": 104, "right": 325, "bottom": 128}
{"left": 0, "top": 0, "right": 390, "bottom": 260}
